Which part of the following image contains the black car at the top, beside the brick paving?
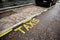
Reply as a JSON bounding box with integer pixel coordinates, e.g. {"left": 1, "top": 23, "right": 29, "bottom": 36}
{"left": 35, "top": 0, "right": 57, "bottom": 7}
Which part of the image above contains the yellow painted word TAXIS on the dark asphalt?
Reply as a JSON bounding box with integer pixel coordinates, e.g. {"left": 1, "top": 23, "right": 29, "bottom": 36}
{"left": 14, "top": 18, "right": 40, "bottom": 34}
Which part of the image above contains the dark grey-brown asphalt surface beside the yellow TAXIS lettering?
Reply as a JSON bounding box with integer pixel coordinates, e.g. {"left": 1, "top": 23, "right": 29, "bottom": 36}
{"left": 1, "top": 4, "right": 60, "bottom": 40}
